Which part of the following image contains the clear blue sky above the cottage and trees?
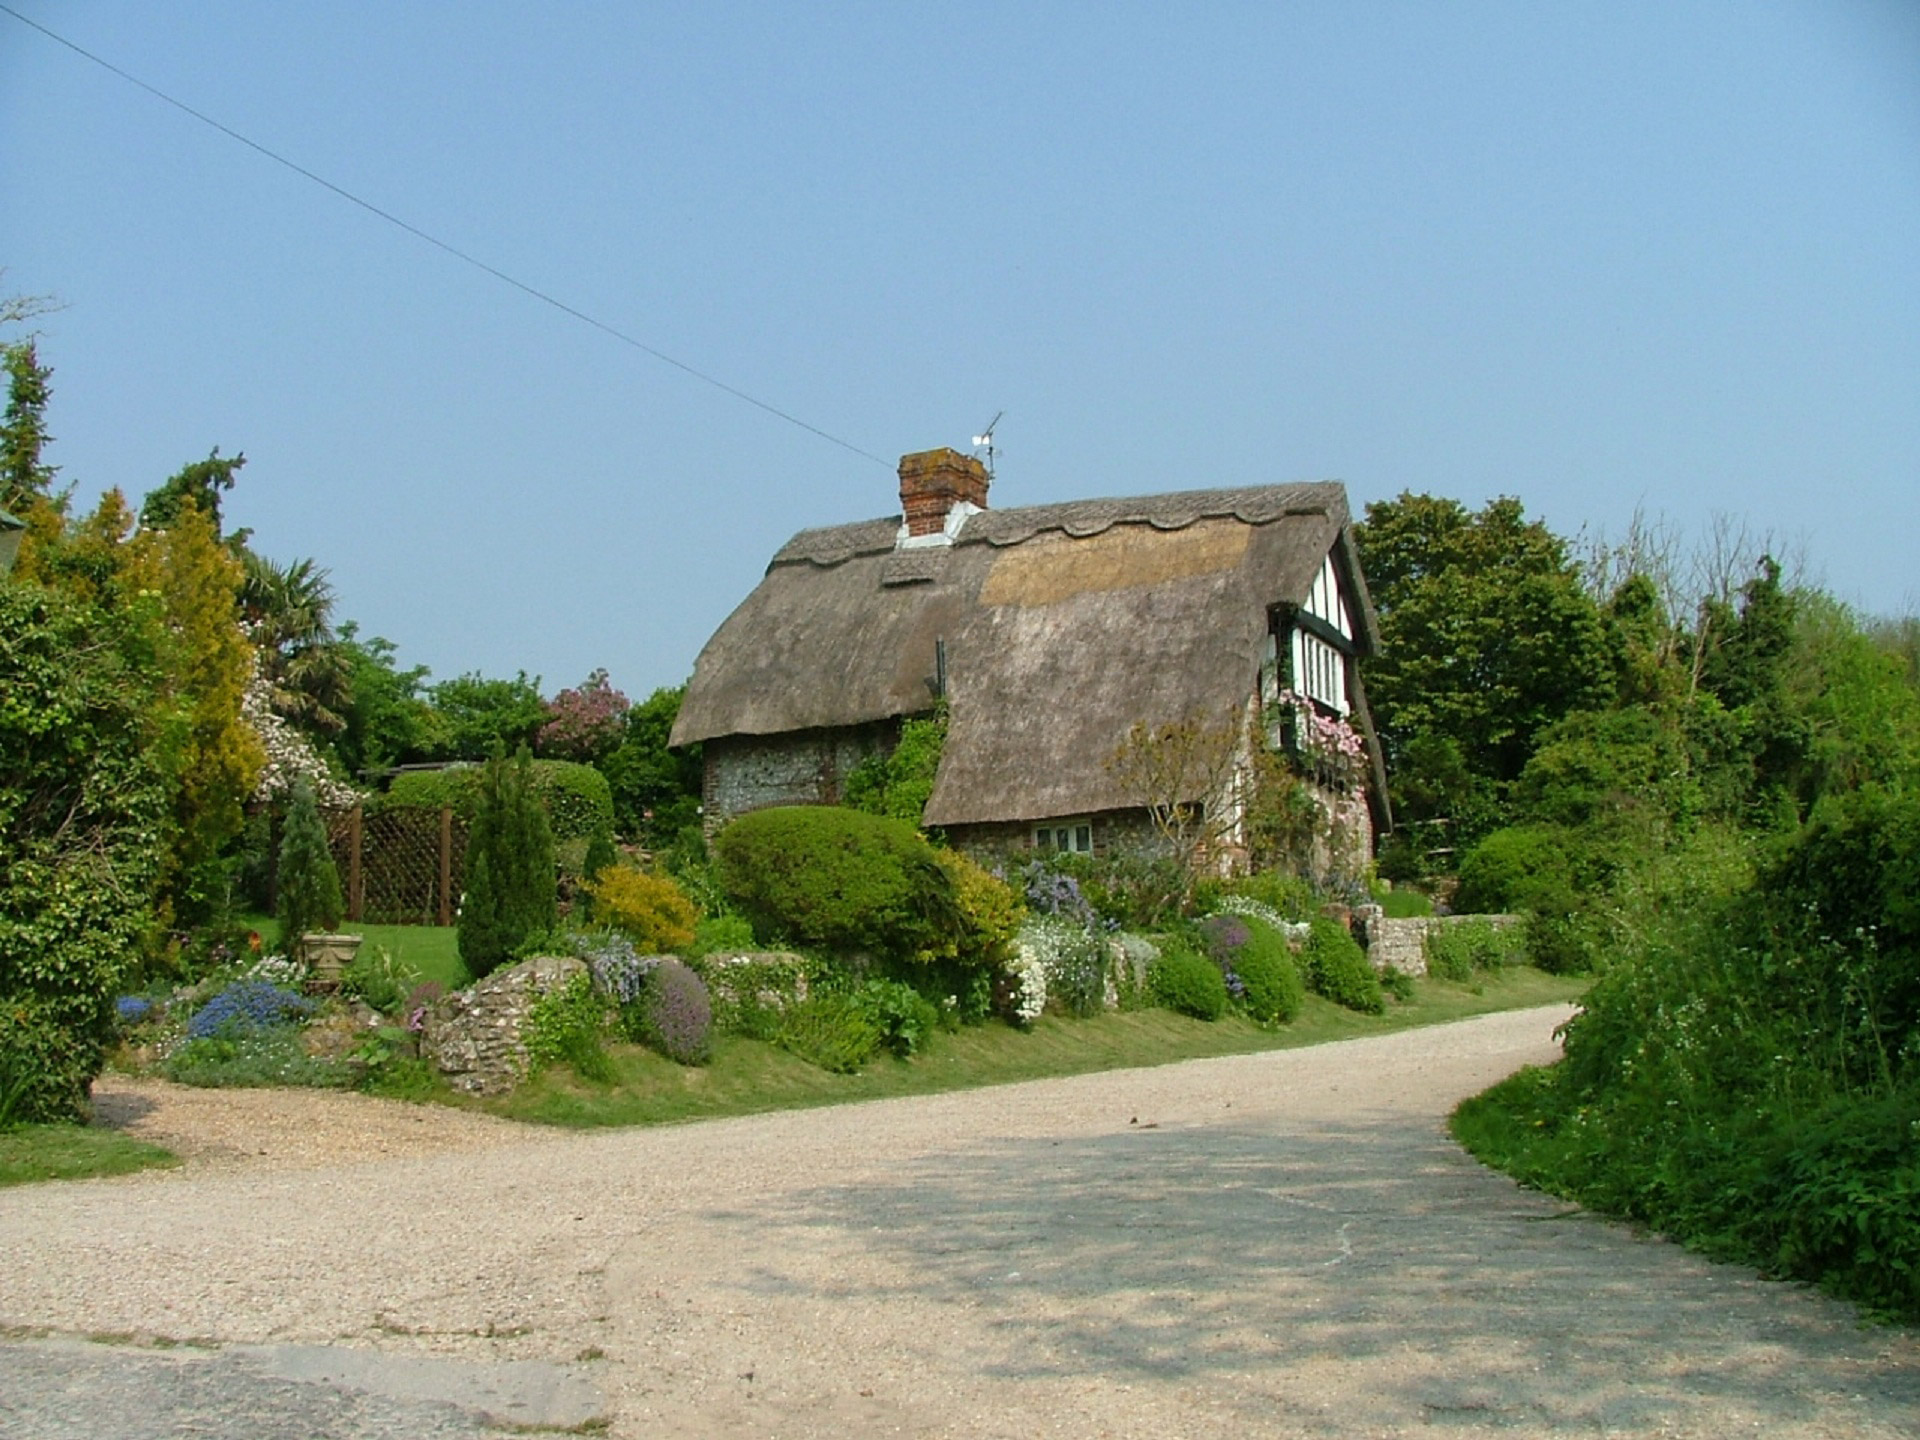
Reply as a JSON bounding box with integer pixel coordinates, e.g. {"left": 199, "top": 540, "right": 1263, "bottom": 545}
{"left": 0, "top": 0, "right": 1920, "bottom": 695}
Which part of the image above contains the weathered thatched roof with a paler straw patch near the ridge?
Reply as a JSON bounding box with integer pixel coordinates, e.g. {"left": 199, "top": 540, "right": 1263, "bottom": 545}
{"left": 672, "top": 484, "right": 1375, "bottom": 826}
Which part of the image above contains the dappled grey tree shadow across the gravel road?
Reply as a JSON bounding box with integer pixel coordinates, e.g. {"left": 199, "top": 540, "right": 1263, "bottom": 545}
{"left": 716, "top": 1117, "right": 1920, "bottom": 1432}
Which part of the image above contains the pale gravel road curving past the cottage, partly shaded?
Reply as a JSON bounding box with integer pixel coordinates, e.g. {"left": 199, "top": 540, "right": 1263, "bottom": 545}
{"left": 0, "top": 1006, "right": 1920, "bottom": 1440}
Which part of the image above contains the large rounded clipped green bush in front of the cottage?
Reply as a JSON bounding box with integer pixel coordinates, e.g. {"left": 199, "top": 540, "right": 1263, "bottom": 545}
{"left": 714, "top": 804, "right": 966, "bottom": 960}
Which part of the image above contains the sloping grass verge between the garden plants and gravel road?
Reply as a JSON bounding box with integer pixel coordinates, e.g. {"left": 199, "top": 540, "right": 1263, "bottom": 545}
{"left": 487, "top": 968, "right": 1590, "bottom": 1127}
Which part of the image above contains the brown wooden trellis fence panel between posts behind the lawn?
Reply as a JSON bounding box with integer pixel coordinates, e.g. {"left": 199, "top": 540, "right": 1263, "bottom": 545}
{"left": 326, "top": 804, "right": 467, "bottom": 925}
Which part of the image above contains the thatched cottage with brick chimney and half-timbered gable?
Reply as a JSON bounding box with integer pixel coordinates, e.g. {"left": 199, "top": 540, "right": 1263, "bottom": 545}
{"left": 672, "top": 449, "right": 1386, "bottom": 852}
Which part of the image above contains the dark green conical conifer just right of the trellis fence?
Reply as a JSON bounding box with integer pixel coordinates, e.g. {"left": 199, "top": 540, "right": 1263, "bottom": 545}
{"left": 459, "top": 745, "right": 559, "bottom": 979}
